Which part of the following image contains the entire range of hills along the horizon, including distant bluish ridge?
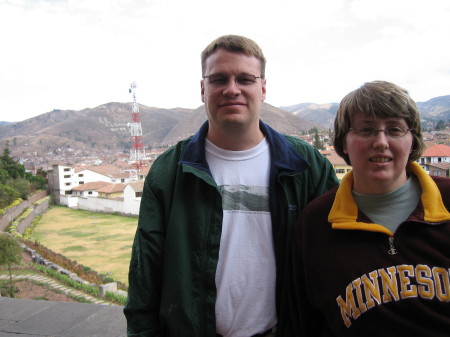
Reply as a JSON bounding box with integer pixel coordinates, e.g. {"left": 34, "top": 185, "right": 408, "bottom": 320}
{"left": 0, "top": 95, "right": 450, "bottom": 165}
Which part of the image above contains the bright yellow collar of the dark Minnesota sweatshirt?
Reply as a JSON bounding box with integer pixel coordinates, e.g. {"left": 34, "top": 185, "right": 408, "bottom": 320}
{"left": 328, "top": 162, "right": 450, "bottom": 235}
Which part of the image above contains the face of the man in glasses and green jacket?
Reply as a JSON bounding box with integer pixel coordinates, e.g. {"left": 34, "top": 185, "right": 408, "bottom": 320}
{"left": 201, "top": 48, "right": 266, "bottom": 132}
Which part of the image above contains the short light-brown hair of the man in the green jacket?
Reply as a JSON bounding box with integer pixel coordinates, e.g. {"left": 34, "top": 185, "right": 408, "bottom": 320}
{"left": 202, "top": 35, "right": 266, "bottom": 78}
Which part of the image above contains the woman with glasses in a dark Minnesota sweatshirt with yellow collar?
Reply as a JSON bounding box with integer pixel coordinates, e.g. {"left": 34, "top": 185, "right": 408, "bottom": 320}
{"left": 293, "top": 81, "right": 450, "bottom": 337}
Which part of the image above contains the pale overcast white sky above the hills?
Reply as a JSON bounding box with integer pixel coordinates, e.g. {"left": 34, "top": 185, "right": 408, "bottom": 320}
{"left": 0, "top": 0, "right": 450, "bottom": 121}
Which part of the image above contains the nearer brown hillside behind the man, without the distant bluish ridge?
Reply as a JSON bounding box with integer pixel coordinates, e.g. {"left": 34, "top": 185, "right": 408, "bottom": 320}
{"left": 0, "top": 103, "right": 322, "bottom": 155}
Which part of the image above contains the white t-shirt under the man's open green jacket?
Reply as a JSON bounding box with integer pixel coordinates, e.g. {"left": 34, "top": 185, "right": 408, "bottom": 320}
{"left": 206, "top": 139, "right": 277, "bottom": 337}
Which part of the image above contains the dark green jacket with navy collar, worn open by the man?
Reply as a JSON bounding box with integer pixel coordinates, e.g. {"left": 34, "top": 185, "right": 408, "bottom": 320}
{"left": 124, "top": 122, "right": 338, "bottom": 337}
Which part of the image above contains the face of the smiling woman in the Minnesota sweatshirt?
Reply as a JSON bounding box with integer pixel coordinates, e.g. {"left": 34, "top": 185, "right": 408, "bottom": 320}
{"left": 344, "top": 113, "right": 413, "bottom": 194}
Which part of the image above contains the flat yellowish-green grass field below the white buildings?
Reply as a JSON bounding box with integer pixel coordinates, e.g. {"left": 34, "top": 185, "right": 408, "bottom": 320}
{"left": 30, "top": 206, "right": 137, "bottom": 284}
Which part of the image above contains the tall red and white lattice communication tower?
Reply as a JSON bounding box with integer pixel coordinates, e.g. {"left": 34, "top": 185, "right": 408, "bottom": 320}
{"left": 128, "top": 82, "right": 145, "bottom": 178}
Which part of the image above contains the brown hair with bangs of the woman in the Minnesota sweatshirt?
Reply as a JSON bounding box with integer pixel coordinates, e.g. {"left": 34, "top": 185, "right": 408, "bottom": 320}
{"left": 334, "top": 81, "right": 425, "bottom": 165}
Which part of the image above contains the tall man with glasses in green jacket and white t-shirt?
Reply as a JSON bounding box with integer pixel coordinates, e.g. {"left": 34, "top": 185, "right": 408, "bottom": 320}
{"left": 124, "top": 35, "right": 337, "bottom": 337}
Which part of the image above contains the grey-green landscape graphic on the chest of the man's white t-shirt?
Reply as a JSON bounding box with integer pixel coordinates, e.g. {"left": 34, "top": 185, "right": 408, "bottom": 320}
{"left": 219, "top": 185, "right": 270, "bottom": 212}
